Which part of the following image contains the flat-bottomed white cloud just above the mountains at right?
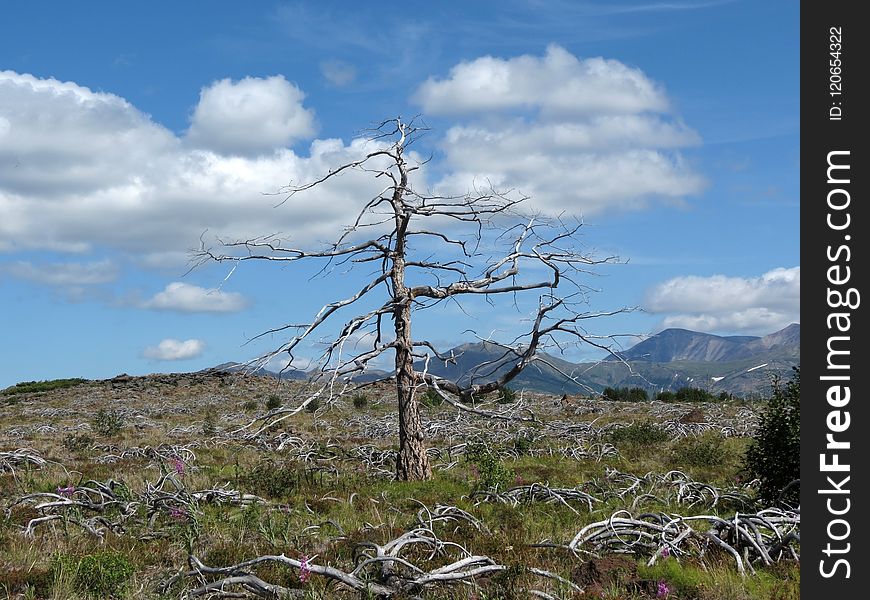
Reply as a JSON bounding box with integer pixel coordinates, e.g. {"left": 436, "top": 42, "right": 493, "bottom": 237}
{"left": 645, "top": 267, "right": 800, "bottom": 334}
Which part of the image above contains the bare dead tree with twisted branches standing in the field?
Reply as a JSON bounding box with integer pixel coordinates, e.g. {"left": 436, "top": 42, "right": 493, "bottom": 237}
{"left": 198, "top": 119, "right": 621, "bottom": 480}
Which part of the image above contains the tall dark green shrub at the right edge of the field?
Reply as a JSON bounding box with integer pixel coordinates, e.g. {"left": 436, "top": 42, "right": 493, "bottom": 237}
{"left": 744, "top": 367, "right": 801, "bottom": 505}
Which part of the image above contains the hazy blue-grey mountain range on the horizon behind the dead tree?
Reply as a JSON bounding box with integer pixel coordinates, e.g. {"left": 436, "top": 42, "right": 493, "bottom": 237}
{"left": 216, "top": 323, "right": 800, "bottom": 397}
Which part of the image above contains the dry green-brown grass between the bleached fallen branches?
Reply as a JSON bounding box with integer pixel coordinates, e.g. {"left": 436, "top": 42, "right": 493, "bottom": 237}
{"left": 0, "top": 374, "right": 799, "bottom": 600}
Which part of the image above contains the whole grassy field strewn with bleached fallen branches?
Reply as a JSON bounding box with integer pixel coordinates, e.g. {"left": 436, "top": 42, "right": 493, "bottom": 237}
{"left": 0, "top": 374, "right": 800, "bottom": 600}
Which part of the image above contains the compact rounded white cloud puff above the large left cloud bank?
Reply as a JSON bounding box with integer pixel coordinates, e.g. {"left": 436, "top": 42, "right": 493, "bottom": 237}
{"left": 187, "top": 75, "right": 315, "bottom": 156}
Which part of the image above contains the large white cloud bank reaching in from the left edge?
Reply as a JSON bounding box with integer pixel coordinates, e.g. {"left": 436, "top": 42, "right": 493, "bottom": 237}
{"left": 0, "top": 71, "right": 398, "bottom": 258}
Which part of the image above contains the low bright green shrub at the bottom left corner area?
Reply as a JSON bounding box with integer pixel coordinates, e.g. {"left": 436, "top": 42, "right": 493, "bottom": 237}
{"left": 52, "top": 550, "right": 136, "bottom": 598}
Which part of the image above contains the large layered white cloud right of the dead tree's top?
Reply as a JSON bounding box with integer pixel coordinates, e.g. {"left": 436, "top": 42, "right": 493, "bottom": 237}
{"left": 413, "top": 46, "right": 704, "bottom": 215}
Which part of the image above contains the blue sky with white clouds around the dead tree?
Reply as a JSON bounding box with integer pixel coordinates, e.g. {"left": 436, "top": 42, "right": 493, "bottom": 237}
{"left": 0, "top": 0, "right": 800, "bottom": 386}
